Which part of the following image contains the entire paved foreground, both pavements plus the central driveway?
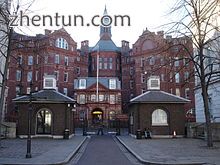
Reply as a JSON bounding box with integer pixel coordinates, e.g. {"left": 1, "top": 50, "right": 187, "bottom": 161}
{"left": 0, "top": 134, "right": 220, "bottom": 165}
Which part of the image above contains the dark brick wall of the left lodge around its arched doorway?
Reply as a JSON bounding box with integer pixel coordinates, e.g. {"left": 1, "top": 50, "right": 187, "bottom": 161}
{"left": 17, "top": 103, "right": 74, "bottom": 138}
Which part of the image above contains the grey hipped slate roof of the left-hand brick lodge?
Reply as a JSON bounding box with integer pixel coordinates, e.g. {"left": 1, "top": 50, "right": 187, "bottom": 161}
{"left": 13, "top": 89, "right": 75, "bottom": 103}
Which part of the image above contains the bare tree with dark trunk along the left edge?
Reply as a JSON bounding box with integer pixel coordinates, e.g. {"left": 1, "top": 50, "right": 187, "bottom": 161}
{"left": 0, "top": 0, "right": 35, "bottom": 147}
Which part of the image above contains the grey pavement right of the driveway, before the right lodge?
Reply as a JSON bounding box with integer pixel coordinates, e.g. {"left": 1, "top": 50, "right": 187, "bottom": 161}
{"left": 117, "top": 136, "right": 220, "bottom": 165}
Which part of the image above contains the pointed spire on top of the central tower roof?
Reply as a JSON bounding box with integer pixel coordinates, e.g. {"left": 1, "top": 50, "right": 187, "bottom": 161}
{"left": 100, "top": 5, "right": 112, "bottom": 39}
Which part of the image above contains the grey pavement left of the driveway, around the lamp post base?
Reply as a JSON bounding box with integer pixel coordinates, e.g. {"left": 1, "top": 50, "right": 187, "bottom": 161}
{"left": 0, "top": 136, "right": 86, "bottom": 165}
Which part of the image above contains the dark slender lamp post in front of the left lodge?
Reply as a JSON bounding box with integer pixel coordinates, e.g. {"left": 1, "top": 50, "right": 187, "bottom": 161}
{"left": 26, "top": 82, "right": 33, "bottom": 158}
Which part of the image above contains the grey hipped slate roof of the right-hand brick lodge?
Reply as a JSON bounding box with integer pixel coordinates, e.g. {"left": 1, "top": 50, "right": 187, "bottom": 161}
{"left": 130, "top": 90, "right": 190, "bottom": 104}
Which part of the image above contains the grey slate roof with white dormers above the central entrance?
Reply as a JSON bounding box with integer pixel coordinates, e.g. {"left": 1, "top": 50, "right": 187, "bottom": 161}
{"left": 74, "top": 77, "right": 121, "bottom": 89}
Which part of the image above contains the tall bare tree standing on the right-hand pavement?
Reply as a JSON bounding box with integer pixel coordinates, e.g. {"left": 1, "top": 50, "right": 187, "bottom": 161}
{"left": 166, "top": 0, "right": 220, "bottom": 147}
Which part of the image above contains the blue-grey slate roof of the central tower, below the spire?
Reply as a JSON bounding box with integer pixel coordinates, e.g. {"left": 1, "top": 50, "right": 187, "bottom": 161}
{"left": 91, "top": 39, "right": 120, "bottom": 52}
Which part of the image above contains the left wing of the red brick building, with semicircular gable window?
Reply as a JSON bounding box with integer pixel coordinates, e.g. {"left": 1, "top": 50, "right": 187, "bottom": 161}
{"left": 6, "top": 28, "right": 88, "bottom": 120}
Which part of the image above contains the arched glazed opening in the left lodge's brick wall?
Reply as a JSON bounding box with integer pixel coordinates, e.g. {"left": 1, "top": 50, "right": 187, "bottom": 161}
{"left": 36, "top": 109, "right": 52, "bottom": 134}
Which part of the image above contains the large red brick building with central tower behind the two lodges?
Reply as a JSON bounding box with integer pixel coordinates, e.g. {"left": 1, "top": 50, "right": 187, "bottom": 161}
{"left": 6, "top": 9, "right": 194, "bottom": 125}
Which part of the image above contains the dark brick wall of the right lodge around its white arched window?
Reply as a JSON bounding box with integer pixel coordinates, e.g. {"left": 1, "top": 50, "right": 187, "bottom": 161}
{"left": 129, "top": 103, "right": 185, "bottom": 135}
